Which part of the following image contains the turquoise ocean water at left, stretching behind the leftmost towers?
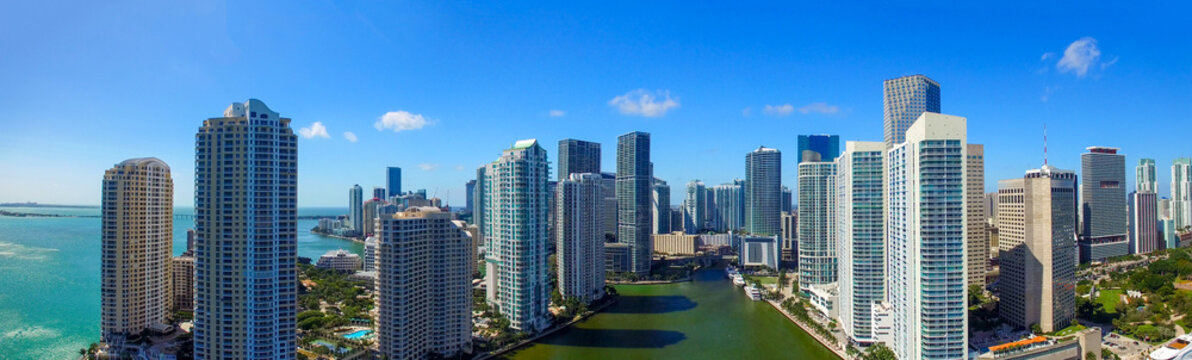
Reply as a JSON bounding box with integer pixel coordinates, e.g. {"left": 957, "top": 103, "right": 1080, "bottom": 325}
{"left": 0, "top": 207, "right": 364, "bottom": 359}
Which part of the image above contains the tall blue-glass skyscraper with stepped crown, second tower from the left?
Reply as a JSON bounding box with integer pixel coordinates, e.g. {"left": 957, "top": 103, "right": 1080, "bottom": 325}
{"left": 194, "top": 99, "right": 298, "bottom": 359}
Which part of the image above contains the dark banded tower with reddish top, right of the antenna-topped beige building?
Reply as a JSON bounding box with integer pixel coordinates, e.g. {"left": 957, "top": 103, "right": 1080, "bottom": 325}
{"left": 1078, "top": 147, "right": 1130, "bottom": 262}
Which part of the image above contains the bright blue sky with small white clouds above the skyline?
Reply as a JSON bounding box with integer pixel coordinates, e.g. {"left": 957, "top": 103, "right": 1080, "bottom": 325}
{"left": 0, "top": 1, "right": 1192, "bottom": 206}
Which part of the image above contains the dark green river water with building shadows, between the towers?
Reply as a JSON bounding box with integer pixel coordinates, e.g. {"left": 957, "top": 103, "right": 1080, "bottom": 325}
{"left": 504, "top": 269, "right": 838, "bottom": 360}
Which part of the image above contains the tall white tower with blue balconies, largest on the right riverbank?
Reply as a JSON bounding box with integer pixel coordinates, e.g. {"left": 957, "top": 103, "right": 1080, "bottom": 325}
{"left": 886, "top": 112, "right": 968, "bottom": 359}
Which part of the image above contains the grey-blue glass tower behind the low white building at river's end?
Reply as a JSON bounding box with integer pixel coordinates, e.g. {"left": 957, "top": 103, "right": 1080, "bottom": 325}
{"left": 745, "top": 147, "right": 781, "bottom": 236}
